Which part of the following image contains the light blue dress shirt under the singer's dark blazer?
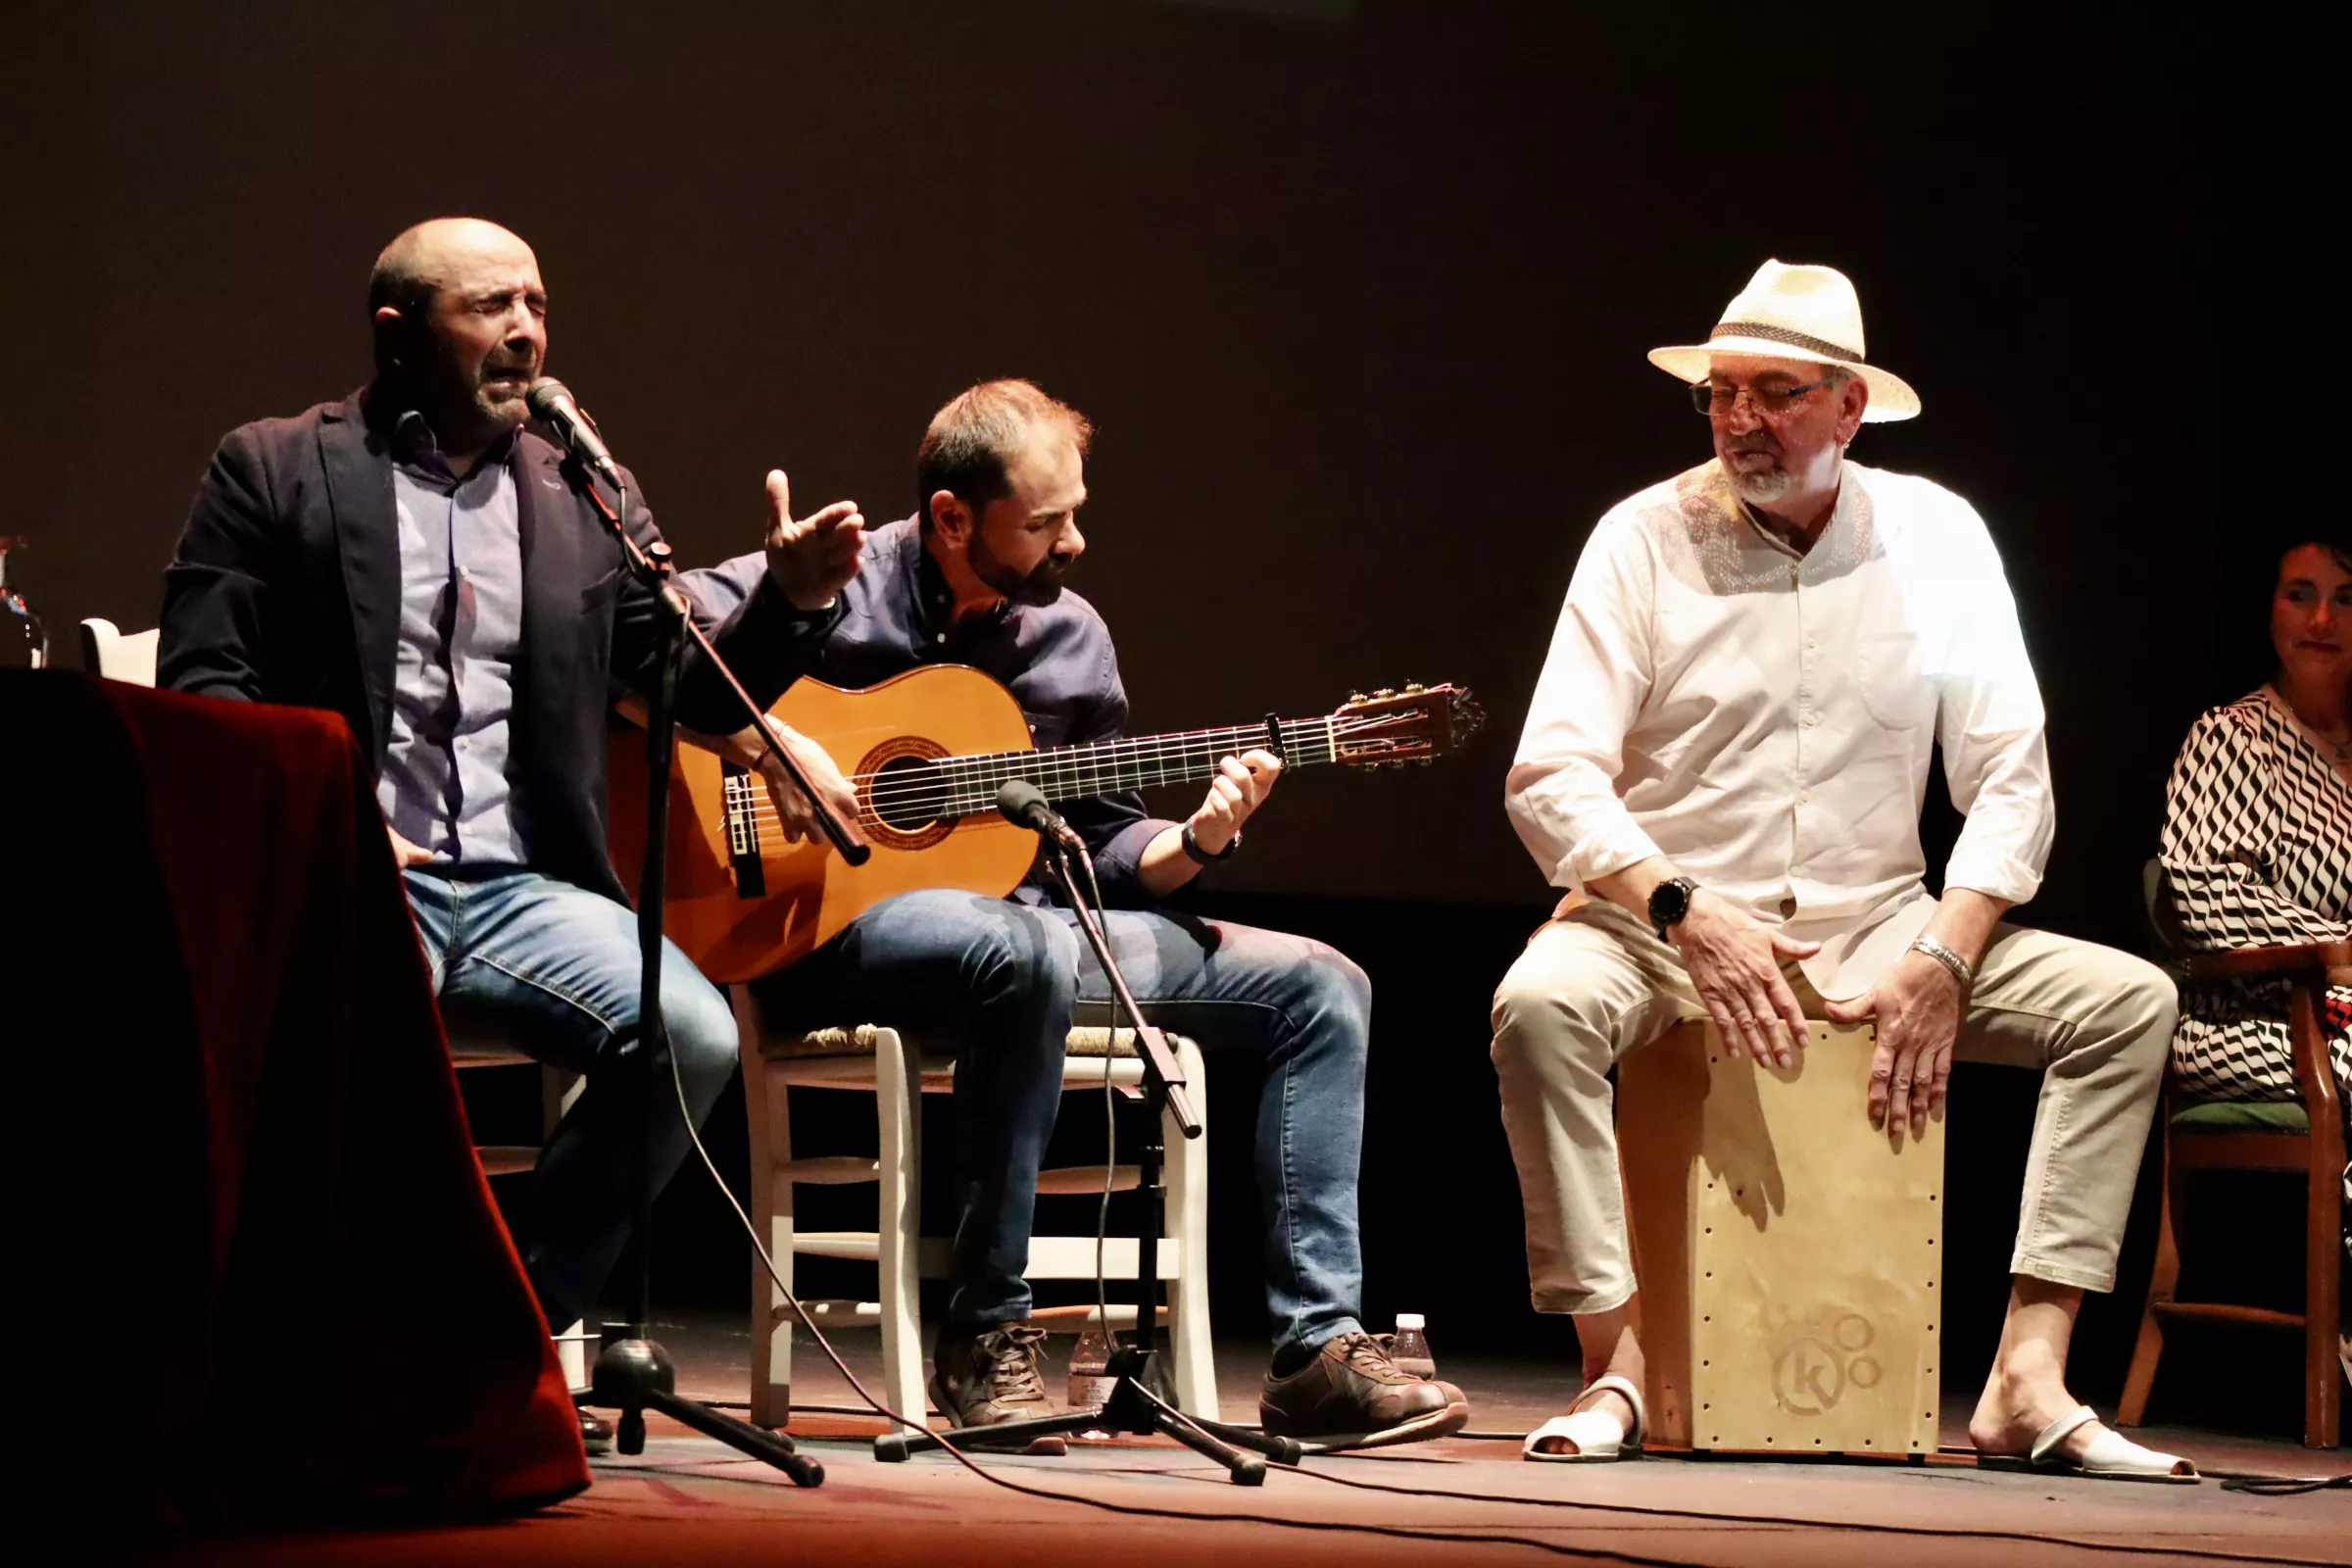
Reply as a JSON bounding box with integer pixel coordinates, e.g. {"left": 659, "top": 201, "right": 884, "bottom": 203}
{"left": 376, "top": 412, "right": 527, "bottom": 867}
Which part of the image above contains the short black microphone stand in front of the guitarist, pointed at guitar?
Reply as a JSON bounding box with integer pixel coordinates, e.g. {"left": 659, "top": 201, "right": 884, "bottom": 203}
{"left": 875, "top": 832, "right": 1305, "bottom": 1486}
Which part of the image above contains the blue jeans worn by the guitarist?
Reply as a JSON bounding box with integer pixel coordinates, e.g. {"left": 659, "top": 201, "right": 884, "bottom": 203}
{"left": 758, "top": 891, "right": 1371, "bottom": 1356}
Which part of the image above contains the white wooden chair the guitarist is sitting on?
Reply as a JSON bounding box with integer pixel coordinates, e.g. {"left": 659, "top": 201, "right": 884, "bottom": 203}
{"left": 731, "top": 1001, "right": 1218, "bottom": 1427}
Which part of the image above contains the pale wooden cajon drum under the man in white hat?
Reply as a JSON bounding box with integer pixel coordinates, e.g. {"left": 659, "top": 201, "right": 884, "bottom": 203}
{"left": 1616, "top": 1022, "right": 1942, "bottom": 1455}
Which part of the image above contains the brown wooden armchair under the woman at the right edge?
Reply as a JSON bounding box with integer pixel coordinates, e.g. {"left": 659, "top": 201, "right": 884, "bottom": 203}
{"left": 2117, "top": 921, "right": 2352, "bottom": 1448}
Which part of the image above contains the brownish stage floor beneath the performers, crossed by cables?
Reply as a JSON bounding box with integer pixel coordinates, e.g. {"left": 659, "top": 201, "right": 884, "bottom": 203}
{"left": 119, "top": 1316, "right": 2352, "bottom": 1568}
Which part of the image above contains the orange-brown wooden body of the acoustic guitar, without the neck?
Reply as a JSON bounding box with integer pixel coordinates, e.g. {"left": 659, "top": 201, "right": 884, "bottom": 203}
{"left": 610, "top": 665, "right": 1037, "bottom": 985}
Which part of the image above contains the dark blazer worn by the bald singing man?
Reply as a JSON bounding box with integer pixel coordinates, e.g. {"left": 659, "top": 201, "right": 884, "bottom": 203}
{"left": 155, "top": 393, "right": 840, "bottom": 898}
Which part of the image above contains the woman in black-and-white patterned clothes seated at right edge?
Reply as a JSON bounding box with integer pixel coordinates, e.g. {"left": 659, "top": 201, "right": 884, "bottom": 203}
{"left": 2162, "top": 543, "right": 2352, "bottom": 1244}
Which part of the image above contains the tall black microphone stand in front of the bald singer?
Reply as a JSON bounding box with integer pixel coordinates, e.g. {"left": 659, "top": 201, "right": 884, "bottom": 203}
{"left": 564, "top": 459, "right": 870, "bottom": 1486}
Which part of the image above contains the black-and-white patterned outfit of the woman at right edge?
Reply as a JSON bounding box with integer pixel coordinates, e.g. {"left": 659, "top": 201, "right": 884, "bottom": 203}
{"left": 2162, "top": 686, "right": 2352, "bottom": 1101}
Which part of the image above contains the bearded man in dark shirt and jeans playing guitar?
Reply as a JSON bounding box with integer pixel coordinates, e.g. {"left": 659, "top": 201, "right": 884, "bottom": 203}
{"left": 684, "top": 381, "right": 1470, "bottom": 1446}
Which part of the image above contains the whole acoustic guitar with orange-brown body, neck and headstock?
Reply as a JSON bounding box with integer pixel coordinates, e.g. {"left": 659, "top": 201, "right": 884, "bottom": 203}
{"left": 610, "top": 665, "right": 1487, "bottom": 983}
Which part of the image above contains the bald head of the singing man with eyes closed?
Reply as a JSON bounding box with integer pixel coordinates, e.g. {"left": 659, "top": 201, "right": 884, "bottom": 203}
{"left": 367, "top": 219, "right": 548, "bottom": 452}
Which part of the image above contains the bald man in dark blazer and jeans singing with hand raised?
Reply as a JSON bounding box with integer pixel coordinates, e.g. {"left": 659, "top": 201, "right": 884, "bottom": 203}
{"left": 158, "top": 219, "right": 863, "bottom": 1447}
